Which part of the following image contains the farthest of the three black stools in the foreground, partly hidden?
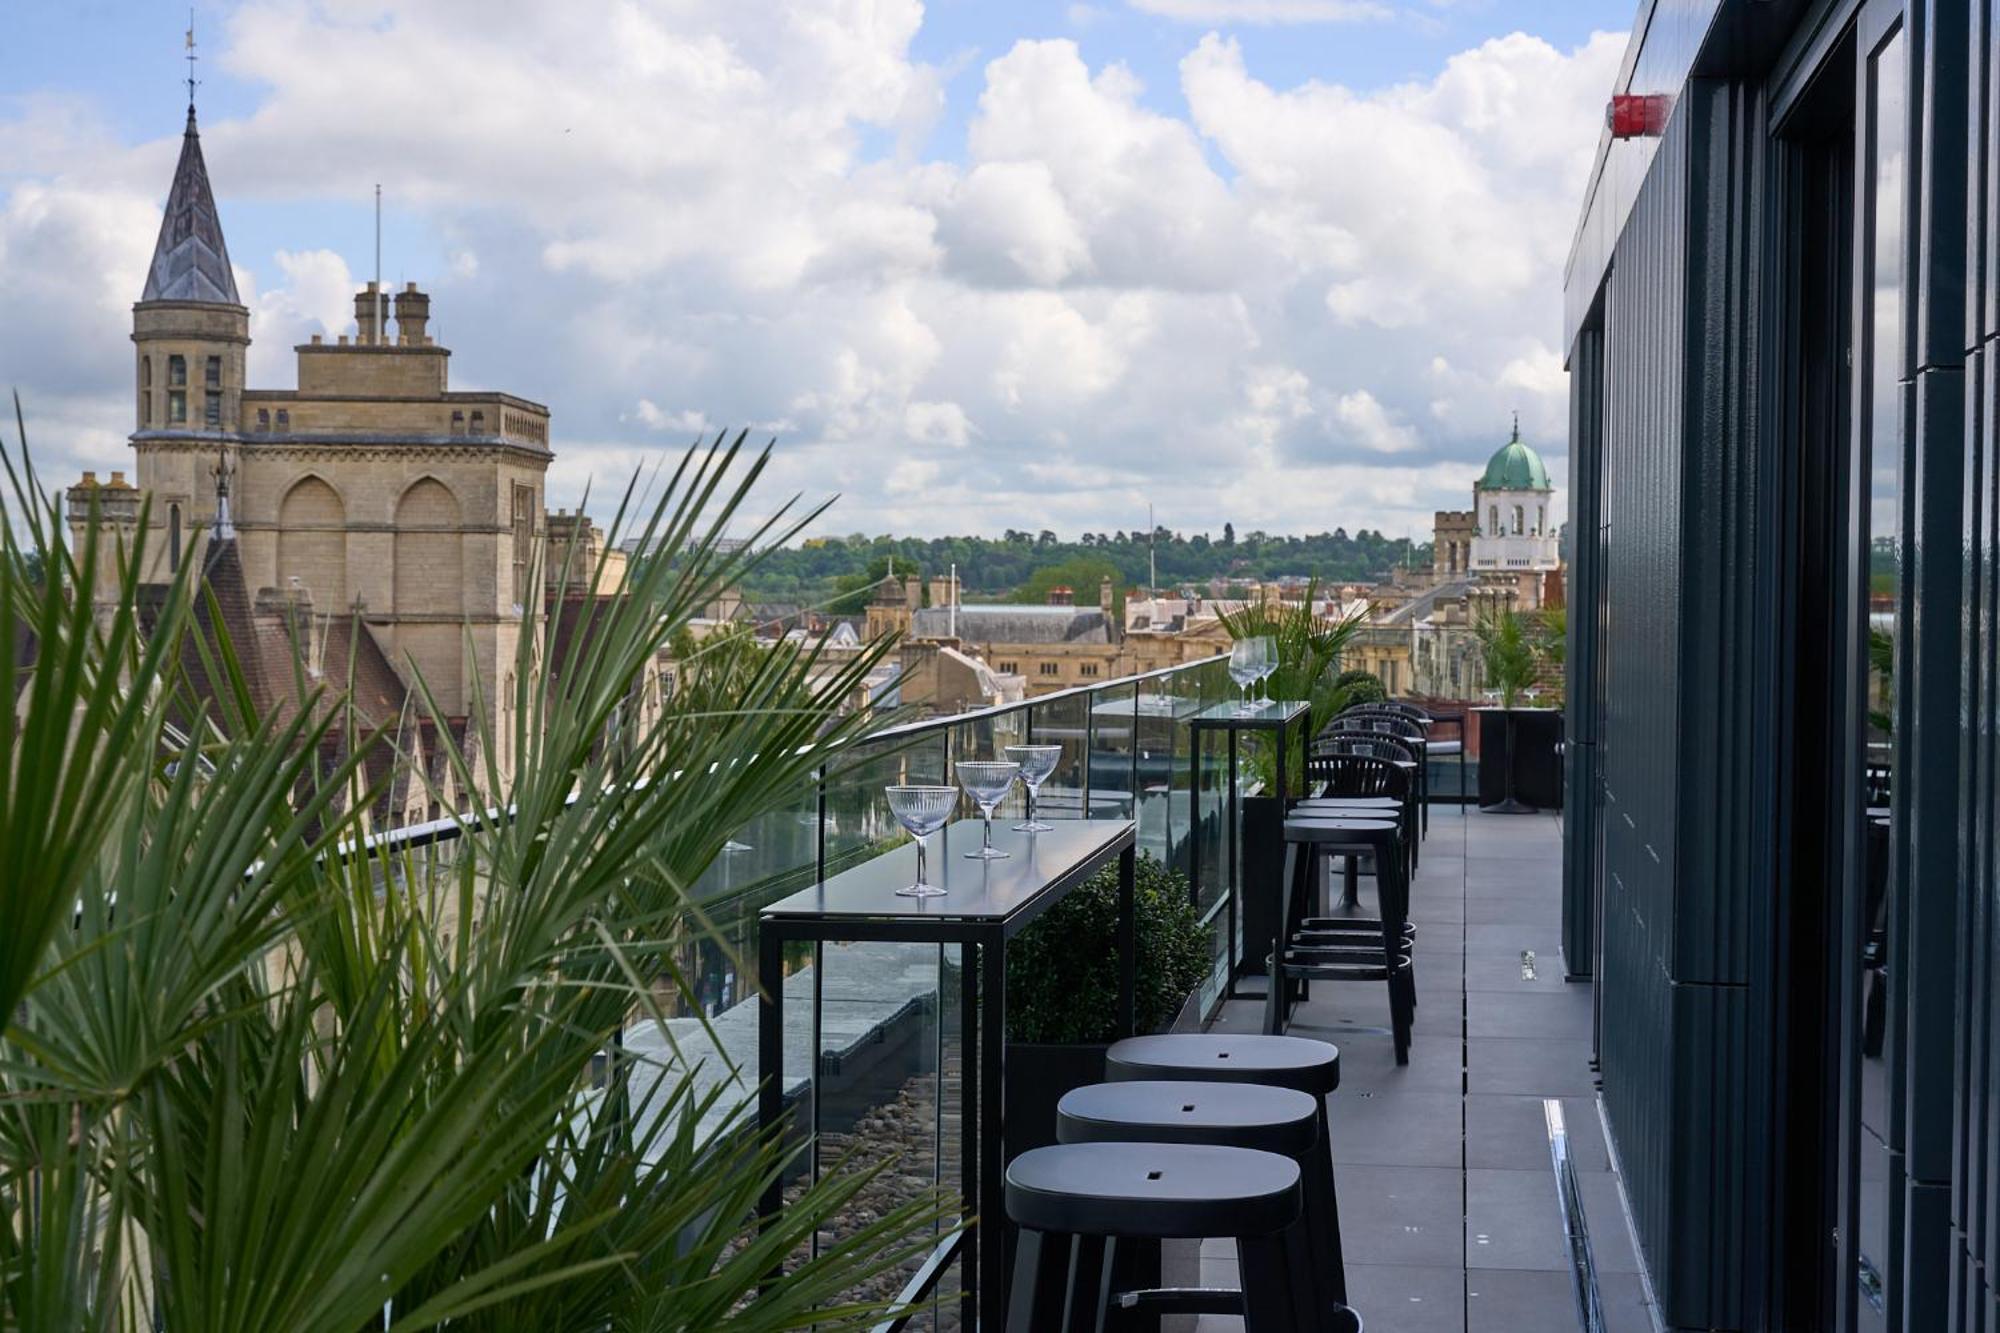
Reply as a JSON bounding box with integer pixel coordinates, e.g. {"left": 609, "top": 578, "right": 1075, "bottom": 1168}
{"left": 1104, "top": 1024, "right": 1348, "bottom": 1303}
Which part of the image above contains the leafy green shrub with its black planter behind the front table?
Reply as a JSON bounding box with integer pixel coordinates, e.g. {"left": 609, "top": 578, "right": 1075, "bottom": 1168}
{"left": 1006, "top": 857, "right": 1212, "bottom": 1155}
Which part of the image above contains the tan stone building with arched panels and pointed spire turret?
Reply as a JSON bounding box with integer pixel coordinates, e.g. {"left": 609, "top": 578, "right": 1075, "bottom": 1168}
{"left": 68, "top": 106, "right": 564, "bottom": 800}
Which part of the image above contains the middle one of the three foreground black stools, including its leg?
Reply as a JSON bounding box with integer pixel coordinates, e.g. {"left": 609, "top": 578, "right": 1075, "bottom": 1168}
{"left": 1056, "top": 1081, "right": 1360, "bottom": 1333}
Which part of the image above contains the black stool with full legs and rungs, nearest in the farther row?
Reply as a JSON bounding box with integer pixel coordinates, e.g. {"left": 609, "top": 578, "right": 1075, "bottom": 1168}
{"left": 1264, "top": 817, "right": 1416, "bottom": 1065}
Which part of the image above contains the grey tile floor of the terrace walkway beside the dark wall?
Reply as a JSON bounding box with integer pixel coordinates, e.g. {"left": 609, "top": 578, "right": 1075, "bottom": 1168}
{"left": 1200, "top": 809, "right": 1654, "bottom": 1333}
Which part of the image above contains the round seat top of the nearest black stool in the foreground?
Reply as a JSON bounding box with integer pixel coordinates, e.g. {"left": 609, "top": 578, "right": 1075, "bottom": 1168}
{"left": 1006, "top": 1143, "right": 1300, "bottom": 1241}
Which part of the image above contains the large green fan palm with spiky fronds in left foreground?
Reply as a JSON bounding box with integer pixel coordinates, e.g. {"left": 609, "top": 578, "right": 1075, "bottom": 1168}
{"left": 0, "top": 410, "right": 948, "bottom": 1333}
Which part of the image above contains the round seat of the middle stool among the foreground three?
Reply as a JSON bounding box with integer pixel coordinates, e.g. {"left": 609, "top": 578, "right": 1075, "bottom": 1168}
{"left": 1056, "top": 1081, "right": 1320, "bottom": 1159}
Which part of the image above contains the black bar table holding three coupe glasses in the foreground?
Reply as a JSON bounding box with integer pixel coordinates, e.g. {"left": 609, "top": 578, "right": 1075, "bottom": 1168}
{"left": 756, "top": 819, "right": 1138, "bottom": 1329}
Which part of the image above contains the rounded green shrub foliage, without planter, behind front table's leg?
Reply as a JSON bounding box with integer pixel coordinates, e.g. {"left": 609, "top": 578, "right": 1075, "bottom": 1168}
{"left": 1006, "top": 857, "right": 1210, "bottom": 1043}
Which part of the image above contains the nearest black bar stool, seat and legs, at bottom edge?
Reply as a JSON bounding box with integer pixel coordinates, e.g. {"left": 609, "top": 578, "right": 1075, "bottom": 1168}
{"left": 1006, "top": 1143, "right": 1312, "bottom": 1333}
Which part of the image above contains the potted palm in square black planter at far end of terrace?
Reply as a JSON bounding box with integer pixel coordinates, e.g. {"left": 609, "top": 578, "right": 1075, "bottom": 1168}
{"left": 1474, "top": 610, "right": 1562, "bottom": 815}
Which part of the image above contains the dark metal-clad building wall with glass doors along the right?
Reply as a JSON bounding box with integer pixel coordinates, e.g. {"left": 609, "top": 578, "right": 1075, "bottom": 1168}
{"left": 1564, "top": 0, "right": 2000, "bottom": 1333}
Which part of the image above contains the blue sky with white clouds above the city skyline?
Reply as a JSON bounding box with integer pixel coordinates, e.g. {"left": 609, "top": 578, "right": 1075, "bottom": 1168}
{"left": 0, "top": 0, "right": 1634, "bottom": 536}
